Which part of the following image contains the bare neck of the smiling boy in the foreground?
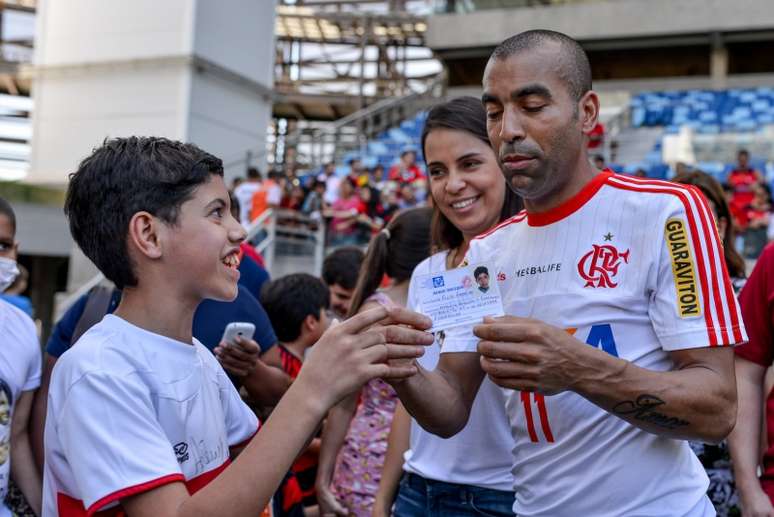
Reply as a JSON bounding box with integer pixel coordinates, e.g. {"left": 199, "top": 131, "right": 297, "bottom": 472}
{"left": 115, "top": 287, "right": 199, "bottom": 344}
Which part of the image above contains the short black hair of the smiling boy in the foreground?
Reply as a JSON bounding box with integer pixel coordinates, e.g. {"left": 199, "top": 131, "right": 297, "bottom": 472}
{"left": 64, "top": 136, "right": 223, "bottom": 289}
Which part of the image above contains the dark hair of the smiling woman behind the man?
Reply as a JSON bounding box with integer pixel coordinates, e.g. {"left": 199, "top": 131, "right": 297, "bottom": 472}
{"left": 422, "top": 97, "right": 524, "bottom": 250}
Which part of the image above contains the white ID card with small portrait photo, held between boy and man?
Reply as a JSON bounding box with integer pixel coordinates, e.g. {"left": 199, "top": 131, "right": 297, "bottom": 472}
{"left": 417, "top": 264, "right": 504, "bottom": 332}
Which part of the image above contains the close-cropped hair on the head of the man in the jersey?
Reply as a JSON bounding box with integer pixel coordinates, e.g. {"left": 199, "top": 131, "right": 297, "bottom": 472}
{"left": 489, "top": 30, "right": 591, "bottom": 100}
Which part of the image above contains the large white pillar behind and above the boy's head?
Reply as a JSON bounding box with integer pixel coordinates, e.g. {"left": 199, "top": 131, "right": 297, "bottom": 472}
{"left": 27, "top": 0, "right": 275, "bottom": 289}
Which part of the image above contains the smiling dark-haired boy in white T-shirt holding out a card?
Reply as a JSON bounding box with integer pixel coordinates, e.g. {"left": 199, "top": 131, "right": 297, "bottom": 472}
{"left": 43, "top": 137, "right": 432, "bottom": 517}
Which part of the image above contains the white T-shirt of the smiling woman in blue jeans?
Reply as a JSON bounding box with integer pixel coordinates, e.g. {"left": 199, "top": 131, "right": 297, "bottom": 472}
{"left": 403, "top": 251, "right": 513, "bottom": 491}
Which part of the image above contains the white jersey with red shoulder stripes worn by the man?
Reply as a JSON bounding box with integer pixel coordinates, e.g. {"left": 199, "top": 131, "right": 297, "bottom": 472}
{"left": 443, "top": 172, "right": 746, "bottom": 517}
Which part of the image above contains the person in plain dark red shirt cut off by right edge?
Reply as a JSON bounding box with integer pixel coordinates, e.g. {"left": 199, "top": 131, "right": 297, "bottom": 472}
{"left": 728, "top": 244, "right": 774, "bottom": 516}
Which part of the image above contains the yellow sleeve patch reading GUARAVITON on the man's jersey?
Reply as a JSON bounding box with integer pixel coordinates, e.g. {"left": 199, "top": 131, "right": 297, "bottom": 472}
{"left": 664, "top": 219, "right": 701, "bottom": 318}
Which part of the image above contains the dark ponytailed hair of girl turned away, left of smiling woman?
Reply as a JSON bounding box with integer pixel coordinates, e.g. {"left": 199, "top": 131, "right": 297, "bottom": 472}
{"left": 347, "top": 207, "right": 432, "bottom": 317}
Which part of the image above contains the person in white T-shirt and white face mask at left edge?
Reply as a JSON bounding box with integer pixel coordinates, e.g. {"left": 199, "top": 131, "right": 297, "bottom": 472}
{"left": 0, "top": 198, "right": 41, "bottom": 517}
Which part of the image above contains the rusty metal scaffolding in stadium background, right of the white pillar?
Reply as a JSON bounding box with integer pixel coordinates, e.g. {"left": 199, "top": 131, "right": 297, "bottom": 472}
{"left": 269, "top": 0, "right": 442, "bottom": 163}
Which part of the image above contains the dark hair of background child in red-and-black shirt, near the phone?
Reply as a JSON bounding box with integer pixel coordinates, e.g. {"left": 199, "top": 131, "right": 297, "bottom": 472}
{"left": 261, "top": 273, "right": 330, "bottom": 343}
